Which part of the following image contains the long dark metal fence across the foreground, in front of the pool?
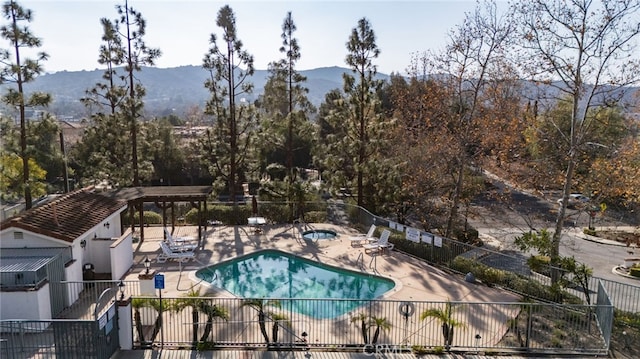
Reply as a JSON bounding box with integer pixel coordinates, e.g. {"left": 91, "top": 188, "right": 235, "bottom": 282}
{"left": 127, "top": 297, "right": 613, "bottom": 355}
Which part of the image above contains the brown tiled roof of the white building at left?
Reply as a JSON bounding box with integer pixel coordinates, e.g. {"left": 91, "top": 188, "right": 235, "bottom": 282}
{"left": 0, "top": 187, "right": 127, "bottom": 243}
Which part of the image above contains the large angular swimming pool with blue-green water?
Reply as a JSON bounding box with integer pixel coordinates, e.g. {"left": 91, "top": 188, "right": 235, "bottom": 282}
{"left": 196, "top": 250, "right": 395, "bottom": 318}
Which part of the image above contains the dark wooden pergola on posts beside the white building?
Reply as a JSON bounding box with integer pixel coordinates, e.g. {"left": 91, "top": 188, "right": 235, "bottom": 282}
{"left": 107, "top": 186, "right": 213, "bottom": 245}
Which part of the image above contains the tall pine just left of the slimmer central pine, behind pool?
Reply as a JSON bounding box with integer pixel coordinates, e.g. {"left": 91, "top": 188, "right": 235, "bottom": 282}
{"left": 199, "top": 5, "right": 257, "bottom": 204}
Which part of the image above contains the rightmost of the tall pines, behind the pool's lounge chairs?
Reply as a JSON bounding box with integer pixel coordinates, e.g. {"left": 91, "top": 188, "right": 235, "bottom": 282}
{"left": 321, "top": 18, "right": 398, "bottom": 213}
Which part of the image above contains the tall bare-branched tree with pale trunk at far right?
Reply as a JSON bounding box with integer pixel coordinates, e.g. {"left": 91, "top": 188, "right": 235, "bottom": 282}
{"left": 513, "top": 0, "right": 640, "bottom": 279}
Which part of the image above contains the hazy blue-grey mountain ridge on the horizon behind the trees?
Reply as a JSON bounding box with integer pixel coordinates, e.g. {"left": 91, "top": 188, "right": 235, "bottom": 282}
{"left": 0, "top": 65, "right": 638, "bottom": 120}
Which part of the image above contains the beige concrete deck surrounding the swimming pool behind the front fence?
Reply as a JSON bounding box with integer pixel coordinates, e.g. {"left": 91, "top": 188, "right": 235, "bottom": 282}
{"left": 123, "top": 224, "right": 518, "bottom": 302}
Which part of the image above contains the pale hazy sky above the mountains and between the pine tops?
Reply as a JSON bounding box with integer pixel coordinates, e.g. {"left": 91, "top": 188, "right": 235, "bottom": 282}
{"left": 11, "top": 0, "right": 504, "bottom": 74}
